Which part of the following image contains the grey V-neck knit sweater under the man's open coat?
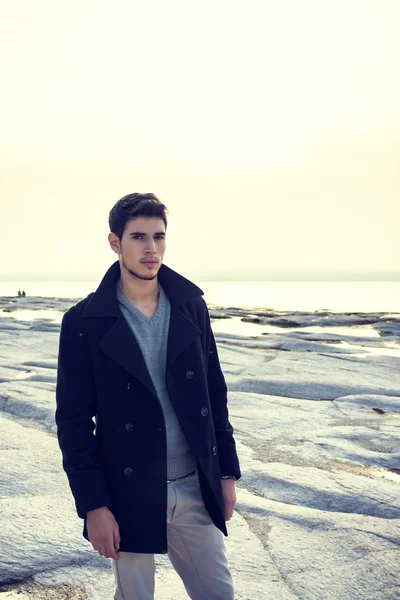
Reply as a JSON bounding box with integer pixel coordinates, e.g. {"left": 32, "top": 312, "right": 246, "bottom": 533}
{"left": 116, "top": 283, "right": 196, "bottom": 479}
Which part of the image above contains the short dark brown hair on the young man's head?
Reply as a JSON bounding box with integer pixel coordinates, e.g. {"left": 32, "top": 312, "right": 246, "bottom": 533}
{"left": 108, "top": 192, "right": 168, "bottom": 240}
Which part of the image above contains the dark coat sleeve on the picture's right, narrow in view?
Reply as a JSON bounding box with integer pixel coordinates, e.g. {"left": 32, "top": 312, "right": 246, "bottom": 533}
{"left": 204, "top": 302, "right": 241, "bottom": 479}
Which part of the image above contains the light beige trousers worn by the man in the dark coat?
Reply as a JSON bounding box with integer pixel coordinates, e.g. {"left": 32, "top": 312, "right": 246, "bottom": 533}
{"left": 111, "top": 472, "right": 234, "bottom": 600}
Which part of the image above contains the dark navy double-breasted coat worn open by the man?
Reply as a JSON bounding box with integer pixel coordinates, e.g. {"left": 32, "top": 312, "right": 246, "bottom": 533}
{"left": 55, "top": 261, "right": 241, "bottom": 554}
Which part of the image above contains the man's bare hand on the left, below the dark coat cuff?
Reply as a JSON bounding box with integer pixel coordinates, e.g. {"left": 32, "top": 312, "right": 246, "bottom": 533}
{"left": 86, "top": 506, "right": 121, "bottom": 560}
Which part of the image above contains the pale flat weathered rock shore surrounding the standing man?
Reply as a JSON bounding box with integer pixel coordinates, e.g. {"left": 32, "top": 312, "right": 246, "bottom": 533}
{"left": 0, "top": 298, "right": 400, "bottom": 600}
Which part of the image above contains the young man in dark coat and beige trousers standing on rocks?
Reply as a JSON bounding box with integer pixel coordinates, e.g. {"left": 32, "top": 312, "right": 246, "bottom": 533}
{"left": 55, "top": 193, "right": 241, "bottom": 600}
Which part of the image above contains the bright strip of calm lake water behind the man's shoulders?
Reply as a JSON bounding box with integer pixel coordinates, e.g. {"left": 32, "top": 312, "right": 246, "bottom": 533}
{"left": 0, "top": 280, "right": 400, "bottom": 313}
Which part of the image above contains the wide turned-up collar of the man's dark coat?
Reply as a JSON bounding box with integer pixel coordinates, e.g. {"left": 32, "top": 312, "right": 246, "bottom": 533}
{"left": 83, "top": 260, "right": 204, "bottom": 318}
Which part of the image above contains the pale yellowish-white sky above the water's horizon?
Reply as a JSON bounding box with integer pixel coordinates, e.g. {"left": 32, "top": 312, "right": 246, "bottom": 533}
{"left": 0, "top": 0, "right": 400, "bottom": 278}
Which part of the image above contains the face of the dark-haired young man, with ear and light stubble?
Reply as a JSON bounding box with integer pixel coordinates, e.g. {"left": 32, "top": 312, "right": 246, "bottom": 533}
{"left": 109, "top": 217, "right": 165, "bottom": 280}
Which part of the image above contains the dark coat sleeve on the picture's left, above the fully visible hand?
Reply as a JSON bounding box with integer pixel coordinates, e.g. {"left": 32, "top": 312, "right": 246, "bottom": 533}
{"left": 55, "top": 307, "right": 111, "bottom": 519}
